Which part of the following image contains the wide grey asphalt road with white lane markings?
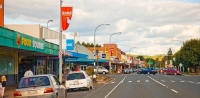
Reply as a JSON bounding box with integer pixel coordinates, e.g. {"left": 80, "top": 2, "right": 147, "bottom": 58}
{"left": 68, "top": 73, "right": 200, "bottom": 98}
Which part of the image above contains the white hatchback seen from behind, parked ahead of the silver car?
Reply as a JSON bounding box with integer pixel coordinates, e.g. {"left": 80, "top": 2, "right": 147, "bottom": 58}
{"left": 65, "top": 71, "right": 93, "bottom": 91}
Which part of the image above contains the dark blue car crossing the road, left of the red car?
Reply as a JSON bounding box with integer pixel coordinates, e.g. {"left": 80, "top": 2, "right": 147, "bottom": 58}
{"left": 138, "top": 67, "right": 157, "bottom": 75}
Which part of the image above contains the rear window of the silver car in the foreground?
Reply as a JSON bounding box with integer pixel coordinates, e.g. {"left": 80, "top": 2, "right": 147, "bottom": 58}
{"left": 18, "top": 76, "right": 50, "bottom": 88}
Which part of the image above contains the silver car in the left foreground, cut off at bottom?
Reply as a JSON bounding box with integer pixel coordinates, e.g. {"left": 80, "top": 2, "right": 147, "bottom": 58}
{"left": 14, "top": 74, "right": 67, "bottom": 98}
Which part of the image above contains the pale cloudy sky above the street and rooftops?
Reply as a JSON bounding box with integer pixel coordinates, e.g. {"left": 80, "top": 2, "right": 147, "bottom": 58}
{"left": 5, "top": 0, "right": 200, "bottom": 55}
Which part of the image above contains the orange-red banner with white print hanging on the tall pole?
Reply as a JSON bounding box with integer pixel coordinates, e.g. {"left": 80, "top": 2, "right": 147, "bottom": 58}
{"left": 62, "top": 7, "right": 73, "bottom": 31}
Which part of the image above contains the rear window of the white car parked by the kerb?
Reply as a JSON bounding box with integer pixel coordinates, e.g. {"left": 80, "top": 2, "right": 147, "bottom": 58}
{"left": 67, "top": 73, "right": 85, "bottom": 80}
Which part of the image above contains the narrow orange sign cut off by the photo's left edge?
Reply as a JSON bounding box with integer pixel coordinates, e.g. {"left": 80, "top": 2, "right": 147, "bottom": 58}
{"left": 0, "top": 0, "right": 4, "bottom": 27}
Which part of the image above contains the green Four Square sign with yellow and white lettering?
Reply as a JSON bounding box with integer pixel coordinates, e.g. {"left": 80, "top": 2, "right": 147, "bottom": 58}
{"left": 15, "top": 32, "right": 45, "bottom": 53}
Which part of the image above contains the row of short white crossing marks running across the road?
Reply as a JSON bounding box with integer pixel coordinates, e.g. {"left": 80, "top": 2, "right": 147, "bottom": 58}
{"left": 112, "top": 79, "right": 200, "bottom": 85}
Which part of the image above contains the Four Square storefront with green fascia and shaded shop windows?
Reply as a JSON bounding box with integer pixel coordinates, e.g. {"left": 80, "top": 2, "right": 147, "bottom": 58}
{"left": 0, "top": 27, "right": 59, "bottom": 84}
